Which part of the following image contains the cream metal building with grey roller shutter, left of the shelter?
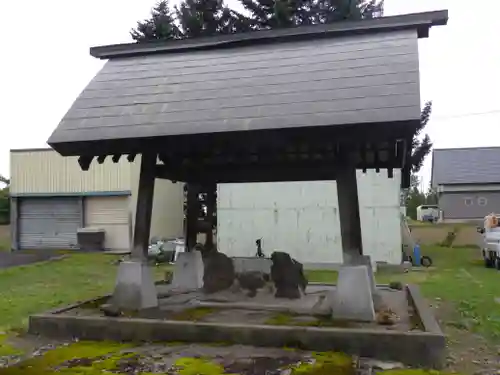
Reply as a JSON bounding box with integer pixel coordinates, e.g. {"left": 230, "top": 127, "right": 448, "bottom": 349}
{"left": 10, "top": 149, "right": 183, "bottom": 250}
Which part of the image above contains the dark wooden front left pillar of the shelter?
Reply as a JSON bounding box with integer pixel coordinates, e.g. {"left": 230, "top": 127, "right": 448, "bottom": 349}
{"left": 132, "top": 153, "right": 156, "bottom": 260}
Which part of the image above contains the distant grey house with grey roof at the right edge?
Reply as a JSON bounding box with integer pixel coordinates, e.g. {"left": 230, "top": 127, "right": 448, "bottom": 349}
{"left": 431, "top": 147, "right": 500, "bottom": 221}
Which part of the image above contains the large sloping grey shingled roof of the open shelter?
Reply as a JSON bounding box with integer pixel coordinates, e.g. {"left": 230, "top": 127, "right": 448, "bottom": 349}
{"left": 48, "top": 12, "right": 447, "bottom": 155}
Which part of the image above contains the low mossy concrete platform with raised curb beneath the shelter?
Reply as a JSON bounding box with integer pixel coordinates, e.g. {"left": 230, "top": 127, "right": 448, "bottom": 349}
{"left": 29, "top": 284, "right": 445, "bottom": 368}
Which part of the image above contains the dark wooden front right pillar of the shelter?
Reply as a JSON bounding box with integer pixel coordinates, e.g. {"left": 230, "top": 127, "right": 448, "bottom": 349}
{"left": 337, "top": 167, "right": 363, "bottom": 263}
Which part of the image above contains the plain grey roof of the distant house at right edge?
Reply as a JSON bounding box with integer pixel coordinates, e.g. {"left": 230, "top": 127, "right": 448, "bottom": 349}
{"left": 432, "top": 147, "right": 500, "bottom": 186}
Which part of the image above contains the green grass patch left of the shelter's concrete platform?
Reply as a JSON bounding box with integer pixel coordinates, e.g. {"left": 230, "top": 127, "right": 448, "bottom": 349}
{"left": 0, "top": 254, "right": 171, "bottom": 329}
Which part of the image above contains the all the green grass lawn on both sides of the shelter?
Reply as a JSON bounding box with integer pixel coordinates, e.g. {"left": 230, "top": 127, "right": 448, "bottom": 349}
{"left": 0, "top": 247, "right": 500, "bottom": 374}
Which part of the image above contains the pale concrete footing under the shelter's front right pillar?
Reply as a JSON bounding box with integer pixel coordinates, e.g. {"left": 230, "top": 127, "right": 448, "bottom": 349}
{"left": 328, "top": 266, "right": 376, "bottom": 322}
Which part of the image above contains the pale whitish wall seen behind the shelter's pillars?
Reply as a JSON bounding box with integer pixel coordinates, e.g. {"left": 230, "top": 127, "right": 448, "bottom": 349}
{"left": 217, "top": 171, "right": 401, "bottom": 264}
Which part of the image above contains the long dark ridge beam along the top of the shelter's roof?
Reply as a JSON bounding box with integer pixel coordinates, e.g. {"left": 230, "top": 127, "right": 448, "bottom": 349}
{"left": 90, "top": 10, "right": 448, "bottom": 59}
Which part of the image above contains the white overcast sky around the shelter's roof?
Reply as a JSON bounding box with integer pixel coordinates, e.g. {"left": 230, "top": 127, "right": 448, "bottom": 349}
{"left": 0, "top": 0, "right": 500, "bottom": 188}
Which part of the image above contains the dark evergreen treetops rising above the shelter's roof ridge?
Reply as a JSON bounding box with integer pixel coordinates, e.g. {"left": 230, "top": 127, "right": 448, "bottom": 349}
{"left": 130, "top": 0, "right": 383, "bottom": 43}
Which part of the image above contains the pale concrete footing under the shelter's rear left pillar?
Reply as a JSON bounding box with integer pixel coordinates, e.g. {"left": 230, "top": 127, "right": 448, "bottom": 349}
{"left": 172, "top": 250, "right": 204, "bottom": 289}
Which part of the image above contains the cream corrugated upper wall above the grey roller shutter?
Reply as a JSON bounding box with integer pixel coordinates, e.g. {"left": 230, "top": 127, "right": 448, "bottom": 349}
{"left": 10, "top": 149, "right": 131, "bottom": 195}
